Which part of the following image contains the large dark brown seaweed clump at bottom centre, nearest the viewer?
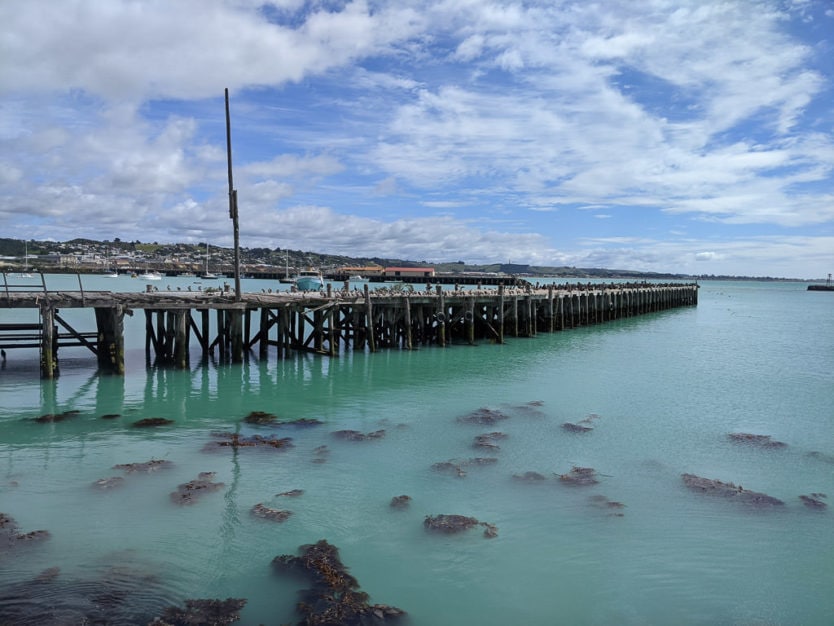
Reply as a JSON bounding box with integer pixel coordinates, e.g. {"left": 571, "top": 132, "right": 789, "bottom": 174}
{"left": 272, "top": 539, "right": 406, "bottom": 626}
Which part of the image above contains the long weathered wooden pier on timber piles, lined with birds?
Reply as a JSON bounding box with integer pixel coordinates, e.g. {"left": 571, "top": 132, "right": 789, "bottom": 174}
{"left": 0, "top": 283, "right": 698, "bottom": 378}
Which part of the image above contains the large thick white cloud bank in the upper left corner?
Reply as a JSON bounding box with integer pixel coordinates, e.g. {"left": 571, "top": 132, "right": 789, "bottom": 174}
{"left": 0, "top": 0, "right": 426, "bottom": 101}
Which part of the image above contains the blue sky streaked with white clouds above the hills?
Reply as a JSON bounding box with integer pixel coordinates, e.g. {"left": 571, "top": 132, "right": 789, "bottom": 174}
{"left": 0, "top": 0, "right": 834, "bottom": 278}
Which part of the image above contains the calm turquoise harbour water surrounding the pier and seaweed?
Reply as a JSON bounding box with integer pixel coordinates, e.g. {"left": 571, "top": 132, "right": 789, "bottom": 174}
{"left": 0, "top": 277, "right": 834, "bottom": 626}
